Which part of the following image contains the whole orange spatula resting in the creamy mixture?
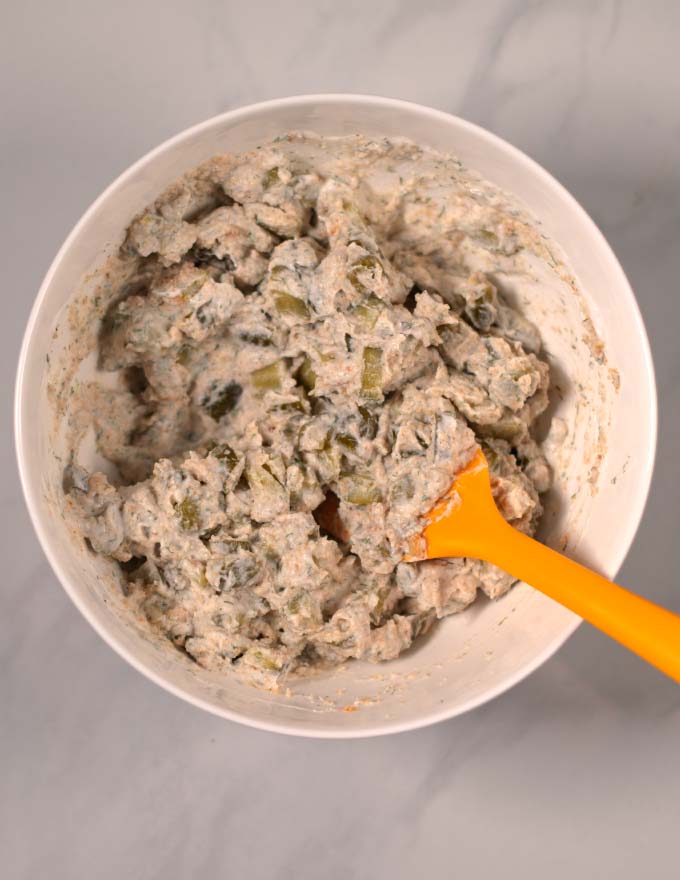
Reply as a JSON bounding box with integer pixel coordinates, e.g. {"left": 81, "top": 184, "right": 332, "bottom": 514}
{"left": 409, "top": 450, "right": 680, "bottom": 682}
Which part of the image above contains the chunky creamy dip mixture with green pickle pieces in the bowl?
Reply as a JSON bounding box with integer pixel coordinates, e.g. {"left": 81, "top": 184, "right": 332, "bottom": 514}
{"left": 66, "top": 134, "right": 550, "bottom": 684}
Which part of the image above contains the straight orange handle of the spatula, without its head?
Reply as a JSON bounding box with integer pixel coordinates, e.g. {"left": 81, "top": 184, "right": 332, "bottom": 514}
{"left": 483, "top": 516, "right": 680, "bottom": 682}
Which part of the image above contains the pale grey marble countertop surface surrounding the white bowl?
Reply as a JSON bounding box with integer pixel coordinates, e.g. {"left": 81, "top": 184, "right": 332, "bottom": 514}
{"left": 0, "top": 0, "right": 680, "bottom": 880}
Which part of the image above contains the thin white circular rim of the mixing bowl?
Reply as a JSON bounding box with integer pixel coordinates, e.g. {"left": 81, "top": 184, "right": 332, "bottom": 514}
{"left": 14, "top": 92, "right": 658, "bottom": 739}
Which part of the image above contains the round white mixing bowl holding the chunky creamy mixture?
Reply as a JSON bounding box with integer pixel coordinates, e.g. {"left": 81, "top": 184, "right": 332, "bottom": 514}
{"left": 16, "top": 95, "right": 656, "bottom": 737}
